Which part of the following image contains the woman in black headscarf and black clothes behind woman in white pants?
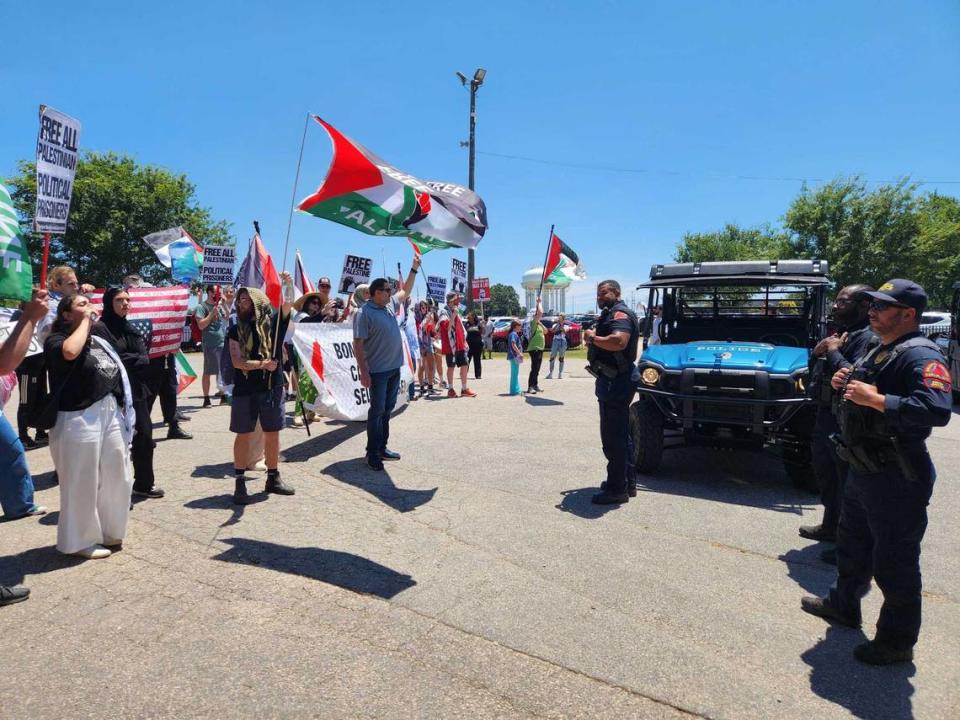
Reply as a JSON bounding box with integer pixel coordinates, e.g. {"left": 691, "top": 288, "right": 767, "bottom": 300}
{"left": 91, "top": 288, "right": 163, "bottom": 498}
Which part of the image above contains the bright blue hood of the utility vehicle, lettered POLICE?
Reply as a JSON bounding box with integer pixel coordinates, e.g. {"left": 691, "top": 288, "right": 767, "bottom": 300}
{"left": 640, "top": 340, "right": 810, "bottom": 375}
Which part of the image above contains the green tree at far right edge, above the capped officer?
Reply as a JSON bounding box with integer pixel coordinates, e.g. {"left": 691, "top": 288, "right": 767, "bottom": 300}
{"left": 914, "top": 193, "right": 960, "bottom": 308}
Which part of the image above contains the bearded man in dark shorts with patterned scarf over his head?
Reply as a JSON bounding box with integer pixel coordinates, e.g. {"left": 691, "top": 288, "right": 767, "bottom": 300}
{"left": 227, "top": 272, "right": 294, "bottom": 505}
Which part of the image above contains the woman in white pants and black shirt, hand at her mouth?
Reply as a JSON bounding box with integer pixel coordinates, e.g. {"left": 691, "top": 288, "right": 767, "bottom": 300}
{"left": 43, "top": 295, "right": 134, "bottom": 558}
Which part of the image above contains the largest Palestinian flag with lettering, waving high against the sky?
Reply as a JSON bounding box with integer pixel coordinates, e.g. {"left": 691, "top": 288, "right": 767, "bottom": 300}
{"left": 297, "top": 116, "right": 487, "bottom": 253}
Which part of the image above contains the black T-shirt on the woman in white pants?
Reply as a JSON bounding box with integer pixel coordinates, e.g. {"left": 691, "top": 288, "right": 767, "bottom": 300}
{"left": 43, "top": 331, "right": 123, "bottom": 412}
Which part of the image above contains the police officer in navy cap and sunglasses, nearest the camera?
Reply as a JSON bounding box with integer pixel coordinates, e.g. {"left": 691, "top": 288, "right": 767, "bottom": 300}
{"left": 801, "top": 279, "right": 952, "bottom": 665}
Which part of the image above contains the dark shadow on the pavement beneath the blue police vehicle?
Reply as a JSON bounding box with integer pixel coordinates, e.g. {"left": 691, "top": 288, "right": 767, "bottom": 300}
{"left": 637, "top": 447, "right": 818, "bottom": 516}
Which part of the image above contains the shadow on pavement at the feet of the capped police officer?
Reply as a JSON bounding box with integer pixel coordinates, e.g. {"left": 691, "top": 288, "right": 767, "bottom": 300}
{"left": 797, "top": 624, "right": 917, "bottom": 720}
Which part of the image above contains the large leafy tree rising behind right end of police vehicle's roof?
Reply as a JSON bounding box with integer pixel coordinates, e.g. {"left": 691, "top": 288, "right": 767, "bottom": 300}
{"left": 784, "top": 177, "right": 921, "bottom": 287}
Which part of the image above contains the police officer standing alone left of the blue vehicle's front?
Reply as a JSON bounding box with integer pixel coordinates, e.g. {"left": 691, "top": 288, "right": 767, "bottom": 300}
{"left": 583, "top": 280, "right": 640, "bottom": 505}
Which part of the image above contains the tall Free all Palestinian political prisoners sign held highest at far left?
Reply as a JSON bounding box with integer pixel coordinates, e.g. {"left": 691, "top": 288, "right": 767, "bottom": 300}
{"left": 33, "top": 105, "right": 80, "bottom": 235}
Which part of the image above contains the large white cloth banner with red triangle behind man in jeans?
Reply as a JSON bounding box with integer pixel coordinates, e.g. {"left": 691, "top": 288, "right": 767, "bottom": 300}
{"left": 293, "top": 322, "right": 413, "bottom": 421}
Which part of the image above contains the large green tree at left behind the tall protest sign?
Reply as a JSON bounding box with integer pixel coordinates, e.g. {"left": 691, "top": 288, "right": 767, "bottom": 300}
{"left": 7, "top": 152, "right": 233, "bottom": 287}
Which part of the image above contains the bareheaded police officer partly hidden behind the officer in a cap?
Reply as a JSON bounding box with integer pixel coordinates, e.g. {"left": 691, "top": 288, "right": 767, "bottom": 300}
{"left": 800, "top": 285, "right": 876, "bottom": 564}
